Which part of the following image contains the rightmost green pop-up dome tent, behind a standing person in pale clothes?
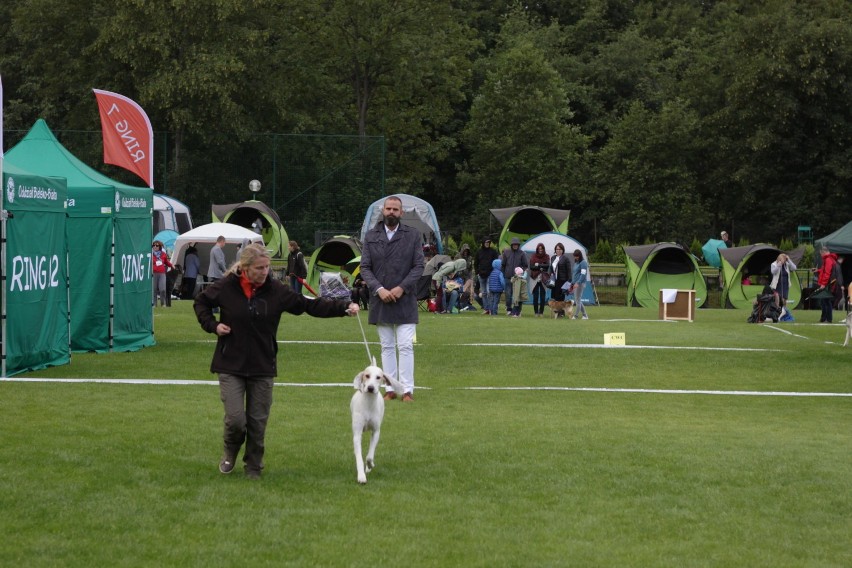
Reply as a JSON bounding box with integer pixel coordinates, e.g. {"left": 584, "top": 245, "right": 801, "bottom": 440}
{"left": 719, "top": 244, "right": 805, "bottom": 310}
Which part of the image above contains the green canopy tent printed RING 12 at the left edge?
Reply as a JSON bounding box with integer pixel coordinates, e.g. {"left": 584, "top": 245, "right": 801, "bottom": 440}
{"left": 0, "top": 162, "right": 71, "bottom": 377}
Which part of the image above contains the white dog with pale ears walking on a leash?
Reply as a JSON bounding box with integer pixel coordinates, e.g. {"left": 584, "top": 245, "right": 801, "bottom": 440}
{"left": 349, "top": 358, "right": 403, "bottom": 484}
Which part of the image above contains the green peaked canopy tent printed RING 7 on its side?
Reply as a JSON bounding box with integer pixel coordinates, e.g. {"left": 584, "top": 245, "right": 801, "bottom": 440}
{"left": 6, "top": 119, "right": 154, "bottom": 352}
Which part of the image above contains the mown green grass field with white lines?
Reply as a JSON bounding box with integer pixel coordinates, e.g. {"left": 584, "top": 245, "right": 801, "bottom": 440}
{"left": 0, "top": 302, "right": 852, "bottom": 567}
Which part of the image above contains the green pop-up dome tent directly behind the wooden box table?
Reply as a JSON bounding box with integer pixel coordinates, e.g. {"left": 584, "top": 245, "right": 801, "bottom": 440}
{"left": 624, "top": 243, "right": 707, "bottom": 308}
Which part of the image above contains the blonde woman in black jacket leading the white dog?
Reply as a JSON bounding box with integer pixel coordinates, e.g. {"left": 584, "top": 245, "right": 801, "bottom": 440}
{"left": 193, "top": 244, "right": 358, "bottom": 479}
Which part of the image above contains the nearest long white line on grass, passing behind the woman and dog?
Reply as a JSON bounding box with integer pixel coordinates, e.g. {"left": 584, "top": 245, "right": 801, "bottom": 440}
{"left": 0, "top": 377, "right": 852, "bottom": 398}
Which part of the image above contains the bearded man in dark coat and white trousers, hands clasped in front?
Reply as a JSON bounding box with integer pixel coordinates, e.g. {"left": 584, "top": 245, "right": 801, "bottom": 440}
{"left": 361, "top": 195, "right": 423, "bottom": 402}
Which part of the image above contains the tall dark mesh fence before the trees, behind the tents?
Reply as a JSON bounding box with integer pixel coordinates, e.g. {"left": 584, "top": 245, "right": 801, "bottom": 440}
{"left": 5, "top": 130, "right": 385, "bottom": 252}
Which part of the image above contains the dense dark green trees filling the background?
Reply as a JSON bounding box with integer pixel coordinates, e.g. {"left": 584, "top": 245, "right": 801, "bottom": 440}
{"left": 0, "top": 0, "right": 852, "bottom": 245}
